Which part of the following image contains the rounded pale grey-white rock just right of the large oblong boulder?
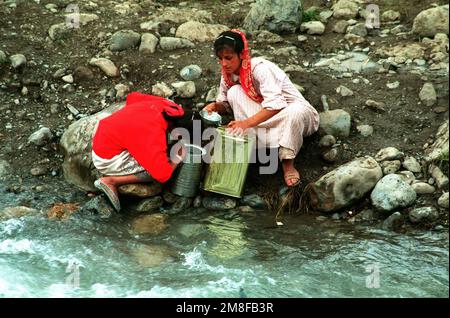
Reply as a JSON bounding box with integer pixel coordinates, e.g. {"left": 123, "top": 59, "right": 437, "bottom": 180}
{"left": 370, "top": 174, "right": 417, "bottom": 211}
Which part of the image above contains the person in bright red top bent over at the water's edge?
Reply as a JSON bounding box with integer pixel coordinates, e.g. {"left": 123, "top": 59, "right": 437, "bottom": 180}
{"left": 92, "top": 92, "right": 185, "bottom": 211}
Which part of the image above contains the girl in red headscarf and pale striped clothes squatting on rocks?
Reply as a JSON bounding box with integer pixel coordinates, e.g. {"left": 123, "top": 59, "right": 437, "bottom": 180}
{"left": 205, "top": 29, "right": 319, "bottom": 187}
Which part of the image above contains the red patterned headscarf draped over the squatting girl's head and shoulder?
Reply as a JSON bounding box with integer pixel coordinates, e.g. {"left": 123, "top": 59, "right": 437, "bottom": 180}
{"left": 222, "top": 29, "right": 264, "bottom": 103}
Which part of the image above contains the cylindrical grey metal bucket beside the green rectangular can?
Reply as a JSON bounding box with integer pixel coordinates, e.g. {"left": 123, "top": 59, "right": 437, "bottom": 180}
{"left": 172, "top": 144, "right": 206, "bottom": 198}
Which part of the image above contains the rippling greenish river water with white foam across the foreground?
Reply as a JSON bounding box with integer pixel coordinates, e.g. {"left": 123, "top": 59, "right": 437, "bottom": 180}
{"left": 0, "top": 181, "right": 449, "bottom": 298}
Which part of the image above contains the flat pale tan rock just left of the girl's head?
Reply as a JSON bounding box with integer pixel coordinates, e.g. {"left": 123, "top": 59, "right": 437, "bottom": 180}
{"left": 175, "top": 21, "right": 229, "bottom": 42}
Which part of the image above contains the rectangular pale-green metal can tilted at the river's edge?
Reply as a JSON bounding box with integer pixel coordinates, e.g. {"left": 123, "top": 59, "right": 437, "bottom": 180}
{"left": 203, "top": 127, "right": 255, "bottom": 198}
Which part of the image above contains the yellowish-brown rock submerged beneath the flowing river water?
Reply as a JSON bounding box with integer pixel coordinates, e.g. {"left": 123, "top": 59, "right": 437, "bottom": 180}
{"left": 131, "top": 244, "right": 173, "bottom": 267}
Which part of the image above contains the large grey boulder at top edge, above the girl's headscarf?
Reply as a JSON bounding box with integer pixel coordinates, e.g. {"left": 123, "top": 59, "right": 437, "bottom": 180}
{"left": 244, "top": 0, "right": 302, "bottom": 33}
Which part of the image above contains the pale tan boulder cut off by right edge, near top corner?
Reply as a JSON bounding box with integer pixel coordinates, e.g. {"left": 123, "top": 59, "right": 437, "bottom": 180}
{"left": 412, "top": 4, "right": 448, "bottom": 36}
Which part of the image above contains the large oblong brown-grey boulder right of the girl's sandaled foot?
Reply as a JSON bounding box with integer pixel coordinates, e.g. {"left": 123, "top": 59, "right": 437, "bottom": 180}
{"left": 307, "top": 156, "right": 383, "bottom": 212}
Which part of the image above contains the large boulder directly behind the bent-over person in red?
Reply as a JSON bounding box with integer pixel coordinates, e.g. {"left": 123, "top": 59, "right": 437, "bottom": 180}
{"left": 60, "top": 103, "right": 124, "bottom": 191}
